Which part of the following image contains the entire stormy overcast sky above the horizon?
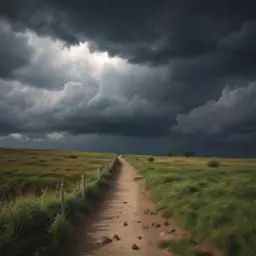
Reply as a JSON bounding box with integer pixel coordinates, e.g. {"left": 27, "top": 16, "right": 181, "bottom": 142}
{"left": 0, "top": 0, "right": 256, "bottom": 157}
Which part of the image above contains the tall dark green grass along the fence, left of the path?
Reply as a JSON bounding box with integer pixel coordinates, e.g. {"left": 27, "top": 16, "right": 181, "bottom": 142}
{"left": 0, "top": 158, "right": 118, "bottom": 256}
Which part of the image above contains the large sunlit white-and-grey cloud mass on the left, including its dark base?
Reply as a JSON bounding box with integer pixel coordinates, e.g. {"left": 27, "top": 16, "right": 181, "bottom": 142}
{"left": 0, "top": 32, "right": 177, "bottom": 137}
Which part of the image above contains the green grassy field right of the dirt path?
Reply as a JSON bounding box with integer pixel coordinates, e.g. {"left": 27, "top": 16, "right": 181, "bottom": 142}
{"left": 127, "top": 156, "right": 256, "bottom": 256}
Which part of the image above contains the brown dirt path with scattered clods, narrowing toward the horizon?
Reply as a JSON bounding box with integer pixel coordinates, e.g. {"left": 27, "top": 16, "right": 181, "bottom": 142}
{"left": 69, "top": 160, "right": 176, "bottom": 256}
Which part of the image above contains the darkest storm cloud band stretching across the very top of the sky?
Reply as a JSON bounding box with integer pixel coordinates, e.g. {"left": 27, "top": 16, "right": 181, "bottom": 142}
{"left": 1, "top": 0, "right": 255, "bottom": 63}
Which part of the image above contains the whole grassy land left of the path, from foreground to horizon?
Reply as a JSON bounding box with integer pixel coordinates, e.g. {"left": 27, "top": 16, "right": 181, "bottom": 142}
{"left": 0, "top": 149, "right": 117, "bottom": 256}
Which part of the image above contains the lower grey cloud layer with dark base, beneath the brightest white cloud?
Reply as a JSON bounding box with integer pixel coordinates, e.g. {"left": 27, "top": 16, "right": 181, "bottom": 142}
{"left": 0, "top": 76, "right": 175, "bottom": 137}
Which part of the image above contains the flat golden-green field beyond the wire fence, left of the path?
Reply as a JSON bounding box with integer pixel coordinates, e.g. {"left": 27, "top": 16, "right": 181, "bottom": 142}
{"left": 0, "top": 148, "right": 114, "bottom": 199}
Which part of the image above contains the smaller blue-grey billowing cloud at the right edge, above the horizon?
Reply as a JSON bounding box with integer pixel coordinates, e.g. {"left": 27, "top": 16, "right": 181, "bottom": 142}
{"left": 172, "top": 82, "right": 256, "bottom": 141}
